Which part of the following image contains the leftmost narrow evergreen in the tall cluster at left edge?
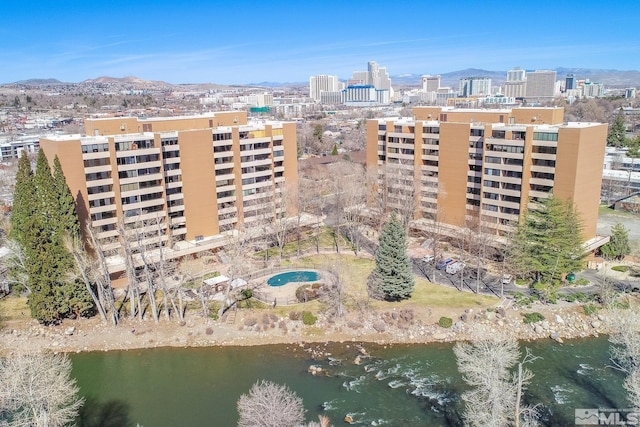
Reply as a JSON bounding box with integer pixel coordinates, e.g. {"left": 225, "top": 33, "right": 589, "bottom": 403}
{"left": 10, "top": 151, "right": 35, "bottom": 246}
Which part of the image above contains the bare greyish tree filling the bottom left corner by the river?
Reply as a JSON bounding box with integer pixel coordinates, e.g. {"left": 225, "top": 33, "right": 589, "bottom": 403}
{"left": 0, "top": 353, "right": 83, "bottom": 427}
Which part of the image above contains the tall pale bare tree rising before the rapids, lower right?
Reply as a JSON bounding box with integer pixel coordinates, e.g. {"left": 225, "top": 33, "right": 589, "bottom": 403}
{"left": 453, "top": 328, "right": 536, "bottom": 427}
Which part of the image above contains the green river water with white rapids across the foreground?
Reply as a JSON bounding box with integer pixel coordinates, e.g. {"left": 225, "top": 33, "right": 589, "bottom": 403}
{"left": 71, "top": 338, "right": 628, "bottom": 427}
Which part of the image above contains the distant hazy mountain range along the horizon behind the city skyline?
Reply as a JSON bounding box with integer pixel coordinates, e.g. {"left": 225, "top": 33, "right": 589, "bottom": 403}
{"left": 7, "top": 68, "right": 640, "bottom": 88}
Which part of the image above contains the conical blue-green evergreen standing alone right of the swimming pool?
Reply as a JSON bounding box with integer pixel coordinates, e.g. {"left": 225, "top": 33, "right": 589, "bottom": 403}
{"left": 370, "top": 214, "right": 414, "bottom": 301}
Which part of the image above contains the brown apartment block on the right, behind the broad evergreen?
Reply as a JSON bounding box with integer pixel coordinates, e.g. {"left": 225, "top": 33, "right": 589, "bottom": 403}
{"left": 367, "top": 107, "right": 607, "bottom": 246}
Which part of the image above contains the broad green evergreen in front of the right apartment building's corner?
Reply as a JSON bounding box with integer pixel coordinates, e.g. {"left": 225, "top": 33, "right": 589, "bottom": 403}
{"left": 509, "top": 197, "right": 585, "bottom": 283}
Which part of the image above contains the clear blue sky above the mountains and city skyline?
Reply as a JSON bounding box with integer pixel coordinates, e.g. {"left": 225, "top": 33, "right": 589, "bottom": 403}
{"left": 0, "top": 0, "right": 640, "bottom": 84}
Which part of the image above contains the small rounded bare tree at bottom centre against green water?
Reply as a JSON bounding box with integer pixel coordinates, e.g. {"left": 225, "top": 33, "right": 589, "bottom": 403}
{"left": 238, "top": 380, "right": 305, "bottom": 427}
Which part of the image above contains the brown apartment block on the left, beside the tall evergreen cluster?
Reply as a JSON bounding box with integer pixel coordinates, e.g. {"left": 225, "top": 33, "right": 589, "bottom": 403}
{"left": 40, "top": 111, "right": 298, "bottom": 270}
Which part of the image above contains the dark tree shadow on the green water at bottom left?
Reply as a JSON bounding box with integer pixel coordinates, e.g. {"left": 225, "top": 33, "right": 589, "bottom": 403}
{"left": 76, "top": 397, "right": 136, "bottom": 427}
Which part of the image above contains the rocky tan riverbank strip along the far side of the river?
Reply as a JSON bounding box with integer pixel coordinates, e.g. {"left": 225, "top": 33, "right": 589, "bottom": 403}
{"left": 0, "top": 303, "right": 607, "bottom": 353}
